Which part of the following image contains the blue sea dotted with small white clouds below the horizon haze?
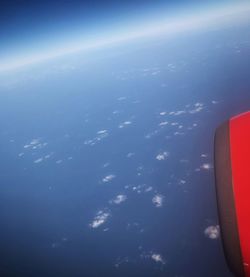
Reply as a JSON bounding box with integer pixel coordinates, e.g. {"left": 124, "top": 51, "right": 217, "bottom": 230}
{"left": 0, "top": 23, "right": 250, "bottom": 277}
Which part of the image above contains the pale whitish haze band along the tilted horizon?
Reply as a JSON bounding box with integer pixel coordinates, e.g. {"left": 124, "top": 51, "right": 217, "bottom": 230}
{"left": 0, "top": 3, "right": 250, "bottom": 73}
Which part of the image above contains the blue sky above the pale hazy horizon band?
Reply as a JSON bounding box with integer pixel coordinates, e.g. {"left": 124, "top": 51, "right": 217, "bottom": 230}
{"left": 0, "top": 0, "right": 247, "bottom": 71}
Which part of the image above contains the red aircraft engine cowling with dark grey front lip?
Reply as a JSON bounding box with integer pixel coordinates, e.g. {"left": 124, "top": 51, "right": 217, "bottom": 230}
{"left": 214, "top": 112, "right": 250, "bottom": 277}
